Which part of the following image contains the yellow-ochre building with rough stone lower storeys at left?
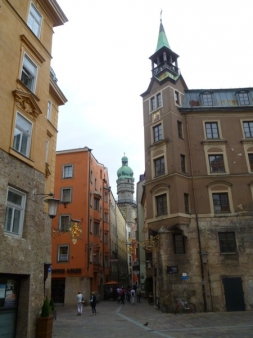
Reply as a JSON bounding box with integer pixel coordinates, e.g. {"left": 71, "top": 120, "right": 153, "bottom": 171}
{"left": 0, "top": 0, "right": 67, "bottom": 338}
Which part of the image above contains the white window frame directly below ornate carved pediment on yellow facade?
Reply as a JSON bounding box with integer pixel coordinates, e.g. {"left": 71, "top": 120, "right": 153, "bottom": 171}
{"left": 13, "top": 111, "right": 33, "bottom": 158}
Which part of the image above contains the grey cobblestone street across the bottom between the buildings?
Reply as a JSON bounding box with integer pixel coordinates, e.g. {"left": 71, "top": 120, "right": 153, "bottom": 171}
{"left": 53, "top": 300, "right": 253, "bottom": 338}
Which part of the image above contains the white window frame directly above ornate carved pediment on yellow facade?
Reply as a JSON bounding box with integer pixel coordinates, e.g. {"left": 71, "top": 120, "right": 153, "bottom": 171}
{"left": 20, "top": 53, "right": 38, "bottom": 93}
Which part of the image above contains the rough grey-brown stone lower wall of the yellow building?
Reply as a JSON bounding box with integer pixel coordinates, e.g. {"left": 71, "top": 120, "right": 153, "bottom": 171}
{"left": 0, "top": 150, "right": 51, "bottom": 338}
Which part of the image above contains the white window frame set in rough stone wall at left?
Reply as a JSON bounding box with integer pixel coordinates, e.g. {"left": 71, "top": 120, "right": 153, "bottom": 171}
{"left": 4, "top": 186, "right": 26, "bottom": 237}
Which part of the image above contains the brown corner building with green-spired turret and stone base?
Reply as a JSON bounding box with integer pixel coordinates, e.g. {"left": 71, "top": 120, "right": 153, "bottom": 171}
{"left": 142, "top": 22, "right": 253, "bottom": 311}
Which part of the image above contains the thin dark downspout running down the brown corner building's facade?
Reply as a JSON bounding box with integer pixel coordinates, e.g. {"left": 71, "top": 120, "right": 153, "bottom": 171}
{"left": 185, "top": 115, "right": 207, "bottom": 312}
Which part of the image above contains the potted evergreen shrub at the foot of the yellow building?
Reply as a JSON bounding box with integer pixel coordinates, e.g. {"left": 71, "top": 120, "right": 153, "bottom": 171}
{"left": 36, "top": 297, "right": 53, "bottom": 338}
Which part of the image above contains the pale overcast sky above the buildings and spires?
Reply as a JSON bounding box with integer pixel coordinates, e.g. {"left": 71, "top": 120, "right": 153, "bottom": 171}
{"left": 52, "top": 0, "right": 253, "bottom": 199}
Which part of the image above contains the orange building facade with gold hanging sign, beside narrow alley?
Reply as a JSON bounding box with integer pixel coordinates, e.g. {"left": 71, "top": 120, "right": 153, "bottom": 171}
{"left": 51, "top": 147, "right": 110, "bottom": 304}
